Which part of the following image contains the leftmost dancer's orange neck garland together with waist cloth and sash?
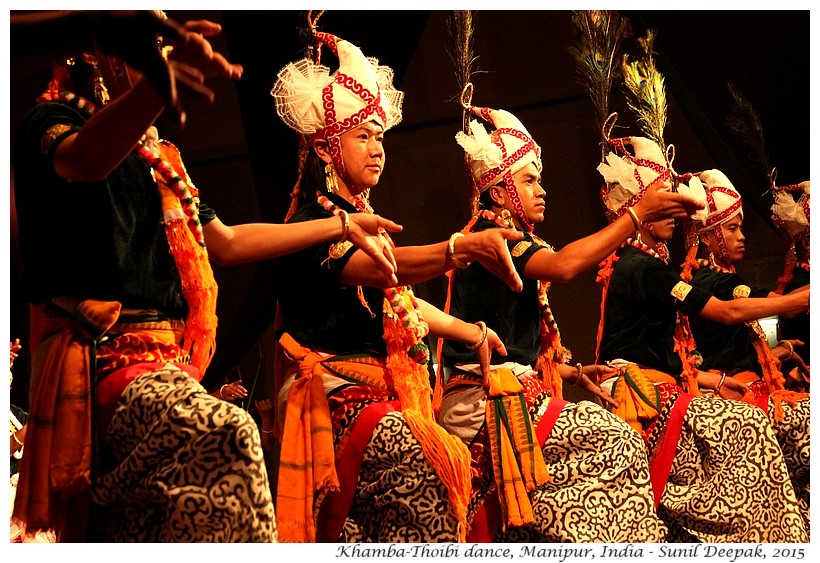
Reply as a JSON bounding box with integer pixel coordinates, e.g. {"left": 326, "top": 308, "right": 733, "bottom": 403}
{"left": 14, "top": 133, "right": 216, "bottom": 541}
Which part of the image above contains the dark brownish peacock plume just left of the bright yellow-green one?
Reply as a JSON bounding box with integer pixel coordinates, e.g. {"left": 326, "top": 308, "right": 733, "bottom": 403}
{"left": 569, "top": 10, "right": 631, "bottom": 135}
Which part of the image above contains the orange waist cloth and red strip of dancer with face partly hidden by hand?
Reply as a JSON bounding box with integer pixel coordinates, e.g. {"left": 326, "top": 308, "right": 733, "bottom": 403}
{"left": 606, "top": 363, "right": 693, "bottom": 508}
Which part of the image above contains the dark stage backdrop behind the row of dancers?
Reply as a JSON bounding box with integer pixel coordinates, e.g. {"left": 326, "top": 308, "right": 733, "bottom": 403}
{"left": 9, "top": 10, "right": 810, "bottom": 434}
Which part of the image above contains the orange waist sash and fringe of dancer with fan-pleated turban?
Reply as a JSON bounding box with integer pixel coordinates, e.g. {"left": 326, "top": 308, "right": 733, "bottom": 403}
{"left": 276, "top": 319, "right": 469, "bottom": 542}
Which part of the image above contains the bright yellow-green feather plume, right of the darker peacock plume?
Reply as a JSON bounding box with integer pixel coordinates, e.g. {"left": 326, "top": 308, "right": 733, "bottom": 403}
{"left": 622, "top": 30, "right": 667, "bottom": 152}
